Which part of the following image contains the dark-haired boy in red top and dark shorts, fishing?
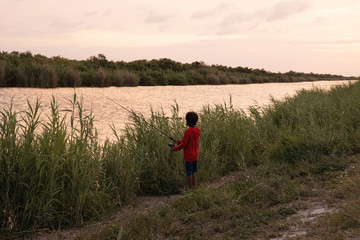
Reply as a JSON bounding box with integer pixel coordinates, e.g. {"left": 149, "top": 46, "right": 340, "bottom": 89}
{"left": 172, "top": 112, "right": 201, "bottom": 189}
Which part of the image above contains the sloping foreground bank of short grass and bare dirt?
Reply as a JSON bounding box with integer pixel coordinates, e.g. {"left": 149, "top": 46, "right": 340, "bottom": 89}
{"left": 30, "top": 155, "right": 360, "bottom": 240}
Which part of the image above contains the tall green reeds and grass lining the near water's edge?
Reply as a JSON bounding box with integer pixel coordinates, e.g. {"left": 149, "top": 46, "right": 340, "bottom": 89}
{"left": 0, "top": 82, "right": 360, "bottom": 234}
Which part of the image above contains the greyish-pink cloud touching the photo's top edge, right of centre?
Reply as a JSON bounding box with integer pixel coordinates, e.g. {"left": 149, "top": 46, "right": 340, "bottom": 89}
{"left": 265, "top": 1, "right": 312, "bottom": 21}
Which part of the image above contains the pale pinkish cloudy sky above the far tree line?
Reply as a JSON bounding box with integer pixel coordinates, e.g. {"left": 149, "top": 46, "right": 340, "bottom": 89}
{"left": 0, "top": 0, "right": 360, "bottom": 76}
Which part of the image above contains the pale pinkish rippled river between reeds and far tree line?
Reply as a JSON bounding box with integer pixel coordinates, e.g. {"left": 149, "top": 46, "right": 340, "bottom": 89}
{"left": 0, "top": 81, "right": 354, "bottom": 140}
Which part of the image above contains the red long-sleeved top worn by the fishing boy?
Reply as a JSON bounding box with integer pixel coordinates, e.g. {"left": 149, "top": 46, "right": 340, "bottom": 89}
{"left": 172, "top": 127, "right": 201, "bottom": 162}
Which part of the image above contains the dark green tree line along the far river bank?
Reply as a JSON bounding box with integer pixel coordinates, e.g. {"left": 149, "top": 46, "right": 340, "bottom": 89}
{"left": 0, "top": 51, "right": 356, "bottom": 88}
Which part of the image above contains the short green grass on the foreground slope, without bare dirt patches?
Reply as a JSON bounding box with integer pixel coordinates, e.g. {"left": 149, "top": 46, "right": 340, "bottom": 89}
{"left": 80, "top": 155, "right": 360, "bottom": 239}
